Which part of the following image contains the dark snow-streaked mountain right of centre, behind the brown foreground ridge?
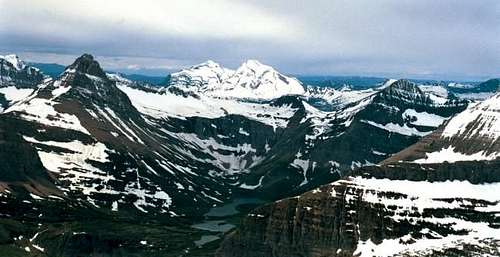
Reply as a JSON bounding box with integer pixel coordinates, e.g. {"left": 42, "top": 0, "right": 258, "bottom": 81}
{"left": 236, "top": 80, "right": 467, "bottom": 195}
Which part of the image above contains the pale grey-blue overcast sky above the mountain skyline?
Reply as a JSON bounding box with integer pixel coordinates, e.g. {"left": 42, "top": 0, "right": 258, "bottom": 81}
{"left": 0, "top": 0, "right": 500, "bottom": 79}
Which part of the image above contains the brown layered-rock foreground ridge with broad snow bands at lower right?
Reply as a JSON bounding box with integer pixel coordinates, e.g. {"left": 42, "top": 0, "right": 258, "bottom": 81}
{"left": 216, "top": 91, "right": 500, "bottom": 257}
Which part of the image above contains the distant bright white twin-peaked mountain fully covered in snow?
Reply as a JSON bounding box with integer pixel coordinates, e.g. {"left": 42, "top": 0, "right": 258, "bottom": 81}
{"left": 169, "top": 60, "right": 304, "bottom": 100}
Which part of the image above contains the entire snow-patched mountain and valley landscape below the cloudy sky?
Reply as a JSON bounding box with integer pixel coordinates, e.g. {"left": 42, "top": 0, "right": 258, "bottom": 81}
{"left": 0, "top": 54, "right": 500, "bottom": 257}
